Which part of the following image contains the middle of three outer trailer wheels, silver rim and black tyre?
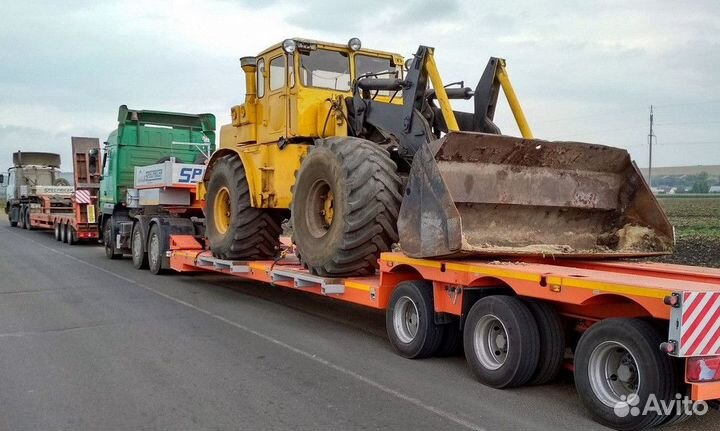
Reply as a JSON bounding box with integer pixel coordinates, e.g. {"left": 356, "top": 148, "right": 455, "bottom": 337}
{"left": 463, "top": 295, "right": 540, "bottom": 388}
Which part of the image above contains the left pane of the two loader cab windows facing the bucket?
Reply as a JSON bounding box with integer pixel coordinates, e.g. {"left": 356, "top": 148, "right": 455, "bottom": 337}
{"left": 299, "top": 49, "right": 350, "bottom": 91}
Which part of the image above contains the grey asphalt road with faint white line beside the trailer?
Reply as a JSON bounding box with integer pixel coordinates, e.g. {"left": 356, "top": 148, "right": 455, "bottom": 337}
{"left": 0, "top": 220, "right": 720, "bottom": 431}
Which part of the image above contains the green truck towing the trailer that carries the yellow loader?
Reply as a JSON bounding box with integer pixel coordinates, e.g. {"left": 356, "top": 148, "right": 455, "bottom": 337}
{"left": 98, "top": 105, "right": 215, "bottom": 273}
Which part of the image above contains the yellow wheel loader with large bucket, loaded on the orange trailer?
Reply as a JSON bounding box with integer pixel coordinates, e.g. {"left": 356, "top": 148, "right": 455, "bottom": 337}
{"left": 199, "top": 38, "right": 673, "bottom": 276}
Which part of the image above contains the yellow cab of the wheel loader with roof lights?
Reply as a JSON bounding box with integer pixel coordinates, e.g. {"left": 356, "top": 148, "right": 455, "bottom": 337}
{"left": 228, "top": 38, "right": 403, "bottom": 147}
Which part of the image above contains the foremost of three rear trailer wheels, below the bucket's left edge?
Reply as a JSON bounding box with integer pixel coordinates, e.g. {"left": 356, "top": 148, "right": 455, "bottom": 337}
{"left": 385, "top": 280, "right": 443, "bottom": 359}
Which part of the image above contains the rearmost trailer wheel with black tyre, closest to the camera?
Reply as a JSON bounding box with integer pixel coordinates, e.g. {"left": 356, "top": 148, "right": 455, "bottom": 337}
{"left": 575, "top": 319, "right": 678, "bottom": 430}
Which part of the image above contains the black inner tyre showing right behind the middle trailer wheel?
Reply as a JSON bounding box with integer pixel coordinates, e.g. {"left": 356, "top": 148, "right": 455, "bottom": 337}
{"left": 524, "top": 300, "right": 565, "bottom": 385}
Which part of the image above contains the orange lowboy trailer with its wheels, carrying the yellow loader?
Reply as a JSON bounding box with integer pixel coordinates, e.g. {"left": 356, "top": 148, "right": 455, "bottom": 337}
{"left": 167, "top": 235, "right": 720, "bottom": 429}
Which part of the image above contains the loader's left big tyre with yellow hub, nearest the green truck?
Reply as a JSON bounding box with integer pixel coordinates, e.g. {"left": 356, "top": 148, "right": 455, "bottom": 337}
{"left": 205, "top": 154, "right": 283, "bottom": 260}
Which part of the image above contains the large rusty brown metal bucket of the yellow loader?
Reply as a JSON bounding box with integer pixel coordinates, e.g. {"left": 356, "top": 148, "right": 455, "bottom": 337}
{"left": 398, "top": 132, "right": 674, "bottom": 258}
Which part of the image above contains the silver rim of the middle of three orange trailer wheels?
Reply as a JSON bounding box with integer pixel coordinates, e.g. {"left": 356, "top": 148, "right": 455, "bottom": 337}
{"left": 473, "top": 314, "right": 510, "bottom": 370}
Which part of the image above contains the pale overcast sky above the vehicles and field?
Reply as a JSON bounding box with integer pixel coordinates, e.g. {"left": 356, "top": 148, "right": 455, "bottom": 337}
{"left": 0, "top": 0, "right": 720, "bottom": 171}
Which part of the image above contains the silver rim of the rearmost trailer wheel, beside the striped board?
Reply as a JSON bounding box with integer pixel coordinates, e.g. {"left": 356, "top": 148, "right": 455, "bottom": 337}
{"left": 588, "top": 341, "right": 641, "bottom": 408}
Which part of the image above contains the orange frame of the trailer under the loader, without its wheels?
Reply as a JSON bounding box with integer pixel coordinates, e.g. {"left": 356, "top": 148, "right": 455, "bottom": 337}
{"left": 168, "top": 235, "right": 720, "bottom": 401}
